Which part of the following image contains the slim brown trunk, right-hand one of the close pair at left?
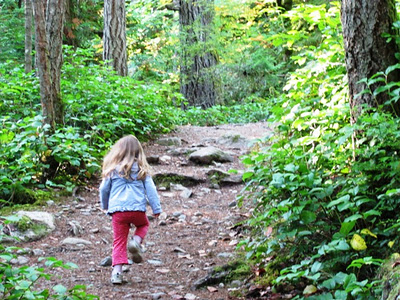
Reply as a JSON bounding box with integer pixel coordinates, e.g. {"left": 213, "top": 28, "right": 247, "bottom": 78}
{"left": 46, "top": 0, "right": 65, "bottom": 124}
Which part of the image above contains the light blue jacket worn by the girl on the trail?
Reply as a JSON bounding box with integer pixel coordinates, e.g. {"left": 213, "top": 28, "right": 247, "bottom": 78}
{"left": 99, "top": 163, "right": 162, "bottom": 215}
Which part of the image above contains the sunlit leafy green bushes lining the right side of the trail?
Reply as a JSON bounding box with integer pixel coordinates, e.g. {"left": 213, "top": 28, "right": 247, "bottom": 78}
{"left": 236, "top": 3, "right": 400, "bottom": 299}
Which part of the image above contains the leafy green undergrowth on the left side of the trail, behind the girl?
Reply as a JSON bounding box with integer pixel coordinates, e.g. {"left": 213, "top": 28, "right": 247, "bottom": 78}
{"left": 0, "top": 48, "right": 181, "bottom": 205}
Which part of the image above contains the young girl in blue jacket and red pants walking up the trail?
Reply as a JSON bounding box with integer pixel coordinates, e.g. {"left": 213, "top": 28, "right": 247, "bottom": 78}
{"left": 100, "top": 135, "right": 161, "bottom": 284}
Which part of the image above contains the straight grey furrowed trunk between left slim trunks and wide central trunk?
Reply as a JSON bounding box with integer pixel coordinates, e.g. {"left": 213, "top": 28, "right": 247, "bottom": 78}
{"left": 103, "top": 0, "right": 128, "bottom": 76}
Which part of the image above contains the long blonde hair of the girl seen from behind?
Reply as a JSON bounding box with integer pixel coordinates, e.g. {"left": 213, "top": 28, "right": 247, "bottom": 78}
{"left": 102, "top": 135, "right": 150, "bottom": 180}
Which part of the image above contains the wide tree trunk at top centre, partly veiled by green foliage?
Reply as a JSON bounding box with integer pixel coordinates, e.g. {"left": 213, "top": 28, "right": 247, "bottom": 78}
{"left": 179, "top": 0, "right": 218, "bottom": 108}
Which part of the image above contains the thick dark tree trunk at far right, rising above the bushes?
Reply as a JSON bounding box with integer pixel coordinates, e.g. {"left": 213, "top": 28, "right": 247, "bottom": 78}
{"left": 341, "top": 0, "right": 400, "bottom": 122}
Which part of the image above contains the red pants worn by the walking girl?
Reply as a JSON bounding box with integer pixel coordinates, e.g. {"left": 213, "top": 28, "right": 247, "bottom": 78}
{"left": 112, "top": 211, "right": 149, "bottom": 266}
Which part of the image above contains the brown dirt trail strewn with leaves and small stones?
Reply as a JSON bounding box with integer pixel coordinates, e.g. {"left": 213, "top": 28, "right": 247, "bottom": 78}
{"left": 15, "top": 122, "right": 270, "bottom": 300}
